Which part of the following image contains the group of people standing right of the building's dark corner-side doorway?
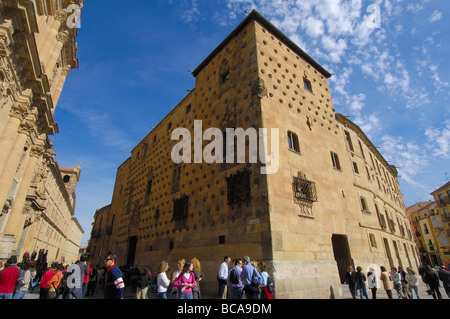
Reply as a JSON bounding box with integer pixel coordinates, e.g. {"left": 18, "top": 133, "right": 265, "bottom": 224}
{"left": 344, "top": 265, "right": 450, "bottom": 299}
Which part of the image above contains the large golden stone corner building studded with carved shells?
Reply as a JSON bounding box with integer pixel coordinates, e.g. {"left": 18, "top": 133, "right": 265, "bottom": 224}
{"left": 89, "top": 11, "right": 418, "bottom": 298}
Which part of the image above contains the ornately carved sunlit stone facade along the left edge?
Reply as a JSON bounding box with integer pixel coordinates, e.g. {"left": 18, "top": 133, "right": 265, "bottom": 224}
{"left": 0, "top": 0, "right": 83, "bottom": 262}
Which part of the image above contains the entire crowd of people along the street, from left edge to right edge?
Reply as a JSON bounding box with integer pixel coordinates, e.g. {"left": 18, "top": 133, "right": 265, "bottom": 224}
{"left": 4, "top": 252, "right": 450, "bottom": 299}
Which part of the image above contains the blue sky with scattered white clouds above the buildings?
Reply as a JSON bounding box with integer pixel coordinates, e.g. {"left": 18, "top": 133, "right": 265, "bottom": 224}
{"left": 52, "top": 0, "right": 450, "bottom": 245}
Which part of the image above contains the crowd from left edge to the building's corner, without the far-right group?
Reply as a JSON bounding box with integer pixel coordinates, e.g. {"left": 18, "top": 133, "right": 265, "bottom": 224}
{"left": 0, "top": 252, "right": 273, "bottom": 299}
